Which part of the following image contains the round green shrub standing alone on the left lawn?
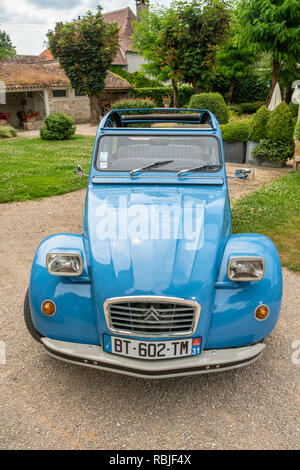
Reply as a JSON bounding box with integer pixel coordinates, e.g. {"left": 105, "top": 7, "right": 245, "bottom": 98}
{"left": 40, "top": 113, "right": 76, "bottom": 140}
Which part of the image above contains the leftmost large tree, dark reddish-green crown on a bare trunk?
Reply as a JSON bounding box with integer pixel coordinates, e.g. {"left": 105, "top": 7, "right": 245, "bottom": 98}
{"left": 47, "top": 6, "right": 119, "bottom": 125}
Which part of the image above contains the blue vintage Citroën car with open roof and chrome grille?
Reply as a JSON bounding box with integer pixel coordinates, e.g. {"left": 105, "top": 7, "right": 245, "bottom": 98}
{"left": 24, "top": 109, "right": 282, "bottom": 378}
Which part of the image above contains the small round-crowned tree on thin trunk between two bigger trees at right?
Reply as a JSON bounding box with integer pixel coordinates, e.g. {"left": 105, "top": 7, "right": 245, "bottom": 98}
{"left": 216, "top": 24, "right": 257, "bottom": 104}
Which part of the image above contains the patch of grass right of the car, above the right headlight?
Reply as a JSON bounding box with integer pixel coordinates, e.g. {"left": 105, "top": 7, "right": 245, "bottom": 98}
{"left": 232, "top": 172, "right": 300, "bottom": 271}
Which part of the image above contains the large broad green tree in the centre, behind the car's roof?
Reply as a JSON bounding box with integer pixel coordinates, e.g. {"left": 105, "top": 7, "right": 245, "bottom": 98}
{"left": 133, "top": 0, "right": 230, "bottom": 102}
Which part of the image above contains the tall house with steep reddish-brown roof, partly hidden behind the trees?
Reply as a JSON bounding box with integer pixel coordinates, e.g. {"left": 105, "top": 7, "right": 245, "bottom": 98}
{"left": 40, "top": 0, "right": 147, "bottom": 73}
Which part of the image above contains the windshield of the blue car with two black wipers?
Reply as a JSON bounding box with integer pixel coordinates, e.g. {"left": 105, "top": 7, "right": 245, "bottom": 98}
{"left": 96, "top": 135, "right": 222, "bottom": 174}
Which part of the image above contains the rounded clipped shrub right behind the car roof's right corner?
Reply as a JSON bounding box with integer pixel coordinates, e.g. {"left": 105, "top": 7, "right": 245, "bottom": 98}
{"left": 189, "top": 93, "right": 228, "bottom": 124}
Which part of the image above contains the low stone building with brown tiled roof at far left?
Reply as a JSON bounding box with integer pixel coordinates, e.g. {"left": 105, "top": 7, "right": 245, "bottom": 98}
{"left": 0, "top": 60, "right": 133, "bottom": 128}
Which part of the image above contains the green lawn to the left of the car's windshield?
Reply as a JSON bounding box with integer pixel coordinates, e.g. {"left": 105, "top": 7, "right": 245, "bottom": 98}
{"left": 0, "top": 135, "right": 94, "bottom": 202}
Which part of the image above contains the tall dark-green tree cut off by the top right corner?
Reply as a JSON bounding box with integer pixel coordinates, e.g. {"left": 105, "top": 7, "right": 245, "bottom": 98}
{"left": 237, "top": 0, "right": 300, "bottom": 105}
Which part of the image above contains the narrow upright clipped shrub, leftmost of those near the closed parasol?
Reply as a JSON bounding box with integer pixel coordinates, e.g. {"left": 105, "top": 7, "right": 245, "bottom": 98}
{"left": 246, "top": 106, "right": 270, "bottom": 165}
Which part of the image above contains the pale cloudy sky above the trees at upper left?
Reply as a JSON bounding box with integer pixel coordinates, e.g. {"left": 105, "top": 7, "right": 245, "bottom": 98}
{"left": 0, "top": 0, "right": 171, "bottom": 55}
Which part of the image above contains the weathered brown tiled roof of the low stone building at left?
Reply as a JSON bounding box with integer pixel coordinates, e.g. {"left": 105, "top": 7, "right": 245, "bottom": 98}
{"left": 0, "top": 62, "right": 132, "bottom": 91}
